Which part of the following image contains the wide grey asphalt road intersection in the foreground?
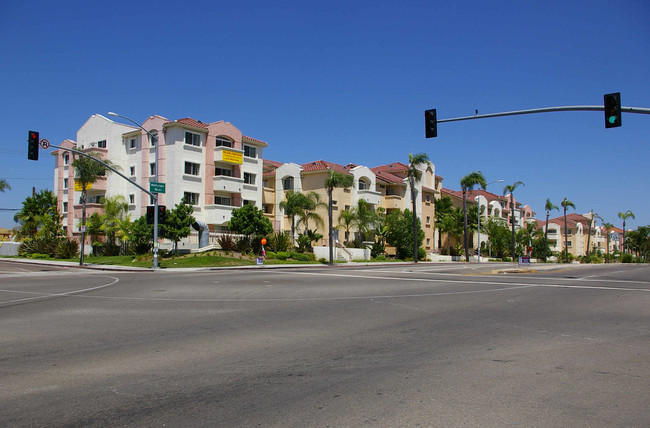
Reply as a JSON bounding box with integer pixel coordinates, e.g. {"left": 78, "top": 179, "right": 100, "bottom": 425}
{"left": 0, "top": 261, "right": 650, "bottom": 427}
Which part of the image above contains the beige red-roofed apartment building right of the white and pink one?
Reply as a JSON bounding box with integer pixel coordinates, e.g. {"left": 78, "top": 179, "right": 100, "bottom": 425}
{"left": 263, "top": 160, "right": 442, "bottom": 252}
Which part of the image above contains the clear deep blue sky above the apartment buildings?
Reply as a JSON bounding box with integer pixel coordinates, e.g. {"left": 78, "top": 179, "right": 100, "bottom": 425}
{"left": 0, "top": 0, "right": 650, "bottom": 228}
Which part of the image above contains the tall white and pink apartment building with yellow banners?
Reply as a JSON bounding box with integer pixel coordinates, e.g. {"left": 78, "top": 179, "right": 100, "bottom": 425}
{"left": 53, "top": 114, "right": 268, "bottom": 241}
